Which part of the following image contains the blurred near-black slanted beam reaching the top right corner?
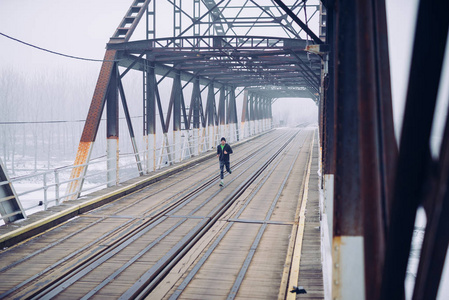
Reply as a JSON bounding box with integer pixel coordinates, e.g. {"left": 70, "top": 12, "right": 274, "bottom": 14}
{"left": 381, "top": 0, "right": 449, "bottom": 299}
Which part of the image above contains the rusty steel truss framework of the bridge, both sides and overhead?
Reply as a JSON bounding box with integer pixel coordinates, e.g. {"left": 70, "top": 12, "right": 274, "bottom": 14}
{"left": 0, "top": 0, "right": 449, "bottom": 299}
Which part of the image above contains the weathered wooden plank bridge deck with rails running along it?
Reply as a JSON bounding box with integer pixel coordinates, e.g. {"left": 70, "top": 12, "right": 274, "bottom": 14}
{"left": 0, "top": 128, "right": 324, "bottom": 299}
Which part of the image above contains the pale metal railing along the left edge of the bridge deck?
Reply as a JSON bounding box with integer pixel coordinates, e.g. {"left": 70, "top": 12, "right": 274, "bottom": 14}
{"left": 0, "top": 126, "right": 248, "bottom": 225}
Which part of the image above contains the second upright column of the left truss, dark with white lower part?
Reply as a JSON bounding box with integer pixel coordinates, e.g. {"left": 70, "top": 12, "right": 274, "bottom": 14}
{"left": 144, "top": 62, "right": 157, "bottom": 172}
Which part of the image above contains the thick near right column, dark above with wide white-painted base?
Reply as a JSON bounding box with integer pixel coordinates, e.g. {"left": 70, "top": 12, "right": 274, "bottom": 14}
{"left": 332, "top": 0, "right": 365, "bottom": 299}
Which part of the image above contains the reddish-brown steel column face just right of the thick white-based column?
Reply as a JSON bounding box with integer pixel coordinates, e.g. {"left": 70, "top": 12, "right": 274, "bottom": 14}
{"left": 356, "top": 0, "right": 388, "bottom": 300}
